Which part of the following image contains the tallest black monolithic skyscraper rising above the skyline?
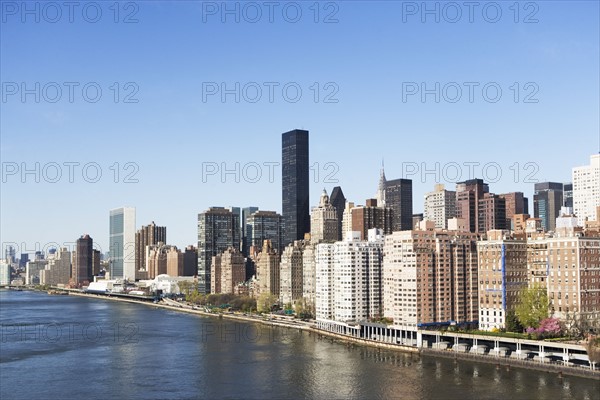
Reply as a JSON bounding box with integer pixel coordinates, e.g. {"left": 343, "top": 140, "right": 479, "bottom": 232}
{"left": 281, "top": 129, "right": 310, "bottom": 246}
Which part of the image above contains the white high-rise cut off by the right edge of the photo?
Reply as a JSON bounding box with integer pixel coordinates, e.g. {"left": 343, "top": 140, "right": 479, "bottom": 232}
{"left": 573, "top": 154, "right": 600, "bottom": 226}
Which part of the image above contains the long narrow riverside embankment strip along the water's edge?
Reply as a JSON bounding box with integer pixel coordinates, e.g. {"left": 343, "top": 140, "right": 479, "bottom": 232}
{"left": 11, "top": 291, "right": 600, "bottom": 380}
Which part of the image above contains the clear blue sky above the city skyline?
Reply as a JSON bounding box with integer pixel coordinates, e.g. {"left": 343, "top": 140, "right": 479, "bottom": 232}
{"left": 0, "top": 0, "right": 600, "bottom": 251}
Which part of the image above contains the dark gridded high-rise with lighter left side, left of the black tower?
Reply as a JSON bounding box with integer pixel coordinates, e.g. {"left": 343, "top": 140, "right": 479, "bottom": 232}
{"left": 198, "top": 207, "right": 240, "bottom": 294}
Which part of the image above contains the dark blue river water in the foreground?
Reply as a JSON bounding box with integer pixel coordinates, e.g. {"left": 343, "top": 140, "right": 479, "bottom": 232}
{"left": 0, "top": 290, "right": 600, "bottom": 400}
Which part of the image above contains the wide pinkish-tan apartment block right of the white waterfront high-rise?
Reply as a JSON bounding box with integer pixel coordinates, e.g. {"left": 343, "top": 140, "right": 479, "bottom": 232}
{"left": 383, "top": 221, "right": 479, "bottom": 330}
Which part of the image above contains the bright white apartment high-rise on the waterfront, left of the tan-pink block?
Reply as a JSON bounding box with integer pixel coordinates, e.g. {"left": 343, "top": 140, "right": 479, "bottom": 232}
{"left": 316, "top": 229, "right": 383, "bottom": 322}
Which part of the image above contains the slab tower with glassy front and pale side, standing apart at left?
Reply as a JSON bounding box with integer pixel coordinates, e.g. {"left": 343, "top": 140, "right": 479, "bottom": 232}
{"left": 109, "top": 207, "right": 135, "bottom": 280}
